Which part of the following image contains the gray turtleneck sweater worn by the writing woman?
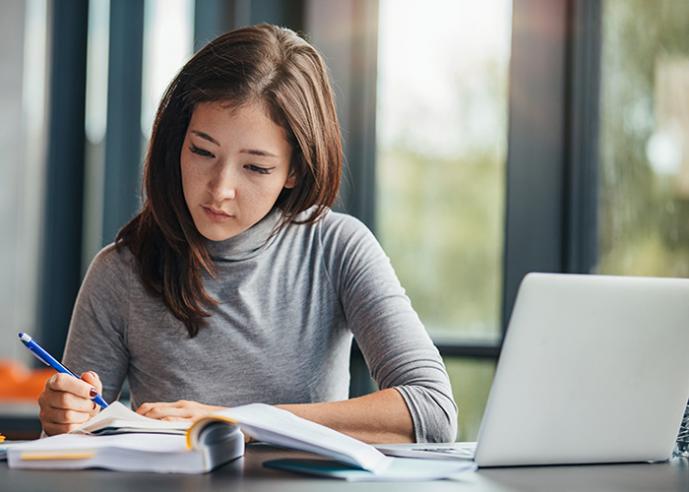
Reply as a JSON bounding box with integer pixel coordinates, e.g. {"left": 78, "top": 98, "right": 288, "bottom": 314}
{"left": 64, "top": 211, "right": 457, "bottom": 442}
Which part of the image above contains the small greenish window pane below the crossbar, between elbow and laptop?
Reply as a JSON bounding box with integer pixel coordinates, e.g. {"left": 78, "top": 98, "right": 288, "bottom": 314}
{"left": 445, "top": 358, "right": 495, "bottom": 441}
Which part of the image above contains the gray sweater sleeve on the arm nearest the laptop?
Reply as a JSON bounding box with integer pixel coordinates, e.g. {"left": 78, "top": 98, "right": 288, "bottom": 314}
{"left": 321, "top": 212, "right": 457, "bottom": 442}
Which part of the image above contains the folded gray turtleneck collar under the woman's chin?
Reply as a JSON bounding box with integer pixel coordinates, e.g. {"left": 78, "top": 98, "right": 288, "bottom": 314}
{"left": 206, "top": 207, "right": 282, "bottom": 261}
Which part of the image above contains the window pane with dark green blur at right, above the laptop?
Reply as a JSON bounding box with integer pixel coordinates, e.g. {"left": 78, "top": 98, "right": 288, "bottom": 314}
{"left": 598, "top": 0, "right": 689, "bottom": 276}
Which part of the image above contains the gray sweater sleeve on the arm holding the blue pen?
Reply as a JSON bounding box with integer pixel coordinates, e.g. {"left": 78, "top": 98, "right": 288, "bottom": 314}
{"left": 63, "top": 245, "right": 130, "bottom": 402}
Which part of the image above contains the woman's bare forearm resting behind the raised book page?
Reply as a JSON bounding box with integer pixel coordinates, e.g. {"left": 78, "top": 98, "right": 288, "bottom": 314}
{"left": 277, "top": 388, "right": 414, "bottom": 443}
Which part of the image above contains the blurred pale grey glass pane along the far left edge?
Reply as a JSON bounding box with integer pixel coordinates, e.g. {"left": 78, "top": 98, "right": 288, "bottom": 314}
{"left": 0, "top": 0, "right": 49, "bottom": 362}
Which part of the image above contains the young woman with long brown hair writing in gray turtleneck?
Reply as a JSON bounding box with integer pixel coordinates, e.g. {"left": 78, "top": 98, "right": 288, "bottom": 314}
{"left": 39, "top": 25, "right": 457, "bottom": 442}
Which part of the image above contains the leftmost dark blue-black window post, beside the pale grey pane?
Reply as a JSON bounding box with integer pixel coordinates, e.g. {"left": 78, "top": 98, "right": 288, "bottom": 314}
{"left": 38, "top": 0, "right": 89, "bottom": 358}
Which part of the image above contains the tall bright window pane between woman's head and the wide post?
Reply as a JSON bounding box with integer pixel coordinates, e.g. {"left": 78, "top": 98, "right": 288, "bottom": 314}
{"left": 376, "top": 0, "right": 512, "bottom": 339}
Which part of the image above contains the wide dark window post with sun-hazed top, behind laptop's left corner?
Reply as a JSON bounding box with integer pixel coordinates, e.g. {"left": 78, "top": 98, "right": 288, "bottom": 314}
{"left": 502, "top": 0, "right": 570, "bottom": 332}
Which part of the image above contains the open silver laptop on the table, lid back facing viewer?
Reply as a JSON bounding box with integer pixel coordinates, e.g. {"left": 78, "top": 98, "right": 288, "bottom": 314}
{"left": 382, "top": 273, "right": 689, "bottom": 467}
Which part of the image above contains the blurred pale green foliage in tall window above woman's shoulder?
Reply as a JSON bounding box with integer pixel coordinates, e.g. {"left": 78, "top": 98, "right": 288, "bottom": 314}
{"left": 378, "top": 145, "right": 504, "bottom": 337}
